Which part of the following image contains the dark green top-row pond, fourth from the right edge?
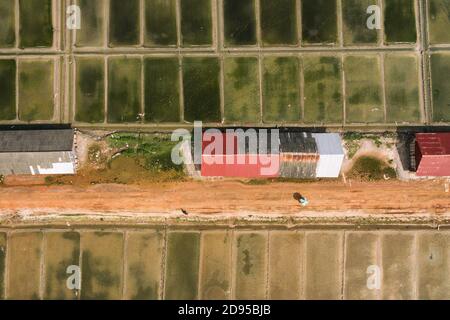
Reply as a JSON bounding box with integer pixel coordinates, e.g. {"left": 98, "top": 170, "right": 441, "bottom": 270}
{"left": 302, "top": 0, "right": 337, "bottom": 43}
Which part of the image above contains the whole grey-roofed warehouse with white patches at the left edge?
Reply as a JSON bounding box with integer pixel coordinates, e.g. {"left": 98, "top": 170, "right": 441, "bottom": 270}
{"left": 0, "top": 129, "right": 75, "bottom": 176}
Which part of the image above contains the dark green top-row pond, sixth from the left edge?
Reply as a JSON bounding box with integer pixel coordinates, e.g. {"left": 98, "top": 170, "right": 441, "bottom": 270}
{"left": 180, "top": 0, "right": 212, "bottom": 46}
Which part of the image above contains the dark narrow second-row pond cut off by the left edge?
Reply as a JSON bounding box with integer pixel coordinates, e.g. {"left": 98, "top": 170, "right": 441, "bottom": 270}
{"left": 0, "top": 60, "right": 16, "bottom": 120}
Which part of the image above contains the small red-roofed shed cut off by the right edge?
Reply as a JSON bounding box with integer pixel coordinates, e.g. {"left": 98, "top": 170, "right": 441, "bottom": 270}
{"left": 415, "top": 133, "right": 450, "bottom": 177}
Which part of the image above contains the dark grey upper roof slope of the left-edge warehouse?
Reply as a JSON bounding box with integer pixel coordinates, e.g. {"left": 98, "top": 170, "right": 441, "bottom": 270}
{"left": 0, "top": 129, "right": 73, "bottom": 152}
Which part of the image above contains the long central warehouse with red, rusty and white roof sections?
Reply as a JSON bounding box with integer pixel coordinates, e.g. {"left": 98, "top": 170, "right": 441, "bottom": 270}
{"left": 200, "top": 131, "right": 344, "bottom": 179}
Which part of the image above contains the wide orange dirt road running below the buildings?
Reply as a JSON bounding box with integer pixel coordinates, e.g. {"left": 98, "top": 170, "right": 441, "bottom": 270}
{"left": 0, "top": 181, "right": 450, "bottom": 214}
